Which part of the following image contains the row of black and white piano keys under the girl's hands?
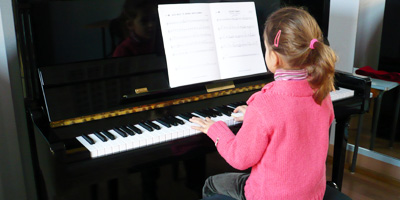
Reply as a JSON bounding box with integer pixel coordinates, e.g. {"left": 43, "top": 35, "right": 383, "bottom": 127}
{"left": 76, "top": 88, "right": 354, "bottom": 158}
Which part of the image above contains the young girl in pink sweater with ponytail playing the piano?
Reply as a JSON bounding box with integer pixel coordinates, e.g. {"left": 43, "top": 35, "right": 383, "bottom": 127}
{"left": 191, "top": 7, "right": 336, "bottom": 200}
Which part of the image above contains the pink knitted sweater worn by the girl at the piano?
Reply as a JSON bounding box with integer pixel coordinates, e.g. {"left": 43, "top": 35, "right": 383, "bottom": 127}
{"left": 207, "top": 80, "right": 334, "bottom": 200}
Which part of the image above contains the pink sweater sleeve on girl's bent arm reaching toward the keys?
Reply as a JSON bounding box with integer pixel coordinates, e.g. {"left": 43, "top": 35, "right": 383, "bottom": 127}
{"left": 207, "top": 105, "right": 268, "bottom": 170}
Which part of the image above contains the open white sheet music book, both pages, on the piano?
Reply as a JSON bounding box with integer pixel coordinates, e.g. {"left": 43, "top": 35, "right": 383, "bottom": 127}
{"left": 158, "top": 2, "right": 267, "bottom": 87}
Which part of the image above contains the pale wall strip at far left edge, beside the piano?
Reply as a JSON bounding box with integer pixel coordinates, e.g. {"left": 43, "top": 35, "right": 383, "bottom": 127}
{"left": 0, "top": 0, "right": 36, "bottom": 200}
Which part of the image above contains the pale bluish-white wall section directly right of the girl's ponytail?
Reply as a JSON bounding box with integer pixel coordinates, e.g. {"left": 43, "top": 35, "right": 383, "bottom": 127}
{"left": 328, "top": 0, "right": 362, "bottom": 73}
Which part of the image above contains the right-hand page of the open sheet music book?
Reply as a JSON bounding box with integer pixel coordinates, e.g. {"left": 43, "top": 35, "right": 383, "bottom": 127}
{"left": 210, "top": 2, "right": 267, "bottom": 79}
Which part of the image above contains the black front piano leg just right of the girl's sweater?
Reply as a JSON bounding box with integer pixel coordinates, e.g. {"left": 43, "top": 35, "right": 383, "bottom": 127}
{"left": 332, "top": 116, "right": 350, "bottom": 190}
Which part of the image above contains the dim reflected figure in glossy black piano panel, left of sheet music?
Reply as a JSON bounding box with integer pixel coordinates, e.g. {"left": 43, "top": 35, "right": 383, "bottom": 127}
{"left": 110, "top": 0, "right": 159, "bottom": 57}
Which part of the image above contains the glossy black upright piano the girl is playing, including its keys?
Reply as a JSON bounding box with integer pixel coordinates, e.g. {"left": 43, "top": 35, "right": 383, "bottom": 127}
{"left": 17, "top": 0, "right": 371, "bottom": 199}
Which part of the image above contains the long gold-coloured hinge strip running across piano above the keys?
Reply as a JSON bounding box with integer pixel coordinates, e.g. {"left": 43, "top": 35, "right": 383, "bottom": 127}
{"left": 50, "top": 83, "right": 265, "bottom": 128}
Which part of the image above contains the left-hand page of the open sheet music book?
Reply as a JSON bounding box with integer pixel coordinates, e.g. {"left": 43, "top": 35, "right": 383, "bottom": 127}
{"left": 158, "top": 4, "right": 220, "bottom": 87}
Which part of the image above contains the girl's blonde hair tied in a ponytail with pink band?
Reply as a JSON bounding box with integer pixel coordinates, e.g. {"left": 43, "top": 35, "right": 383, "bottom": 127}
{"left": 264, "top": 7, "right": 337, "bottom": 104}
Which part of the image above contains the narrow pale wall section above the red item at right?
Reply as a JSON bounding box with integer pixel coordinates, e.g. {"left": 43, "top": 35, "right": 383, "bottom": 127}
{"left": 354, "top": 0, "right": 386, "bottom": 69}
